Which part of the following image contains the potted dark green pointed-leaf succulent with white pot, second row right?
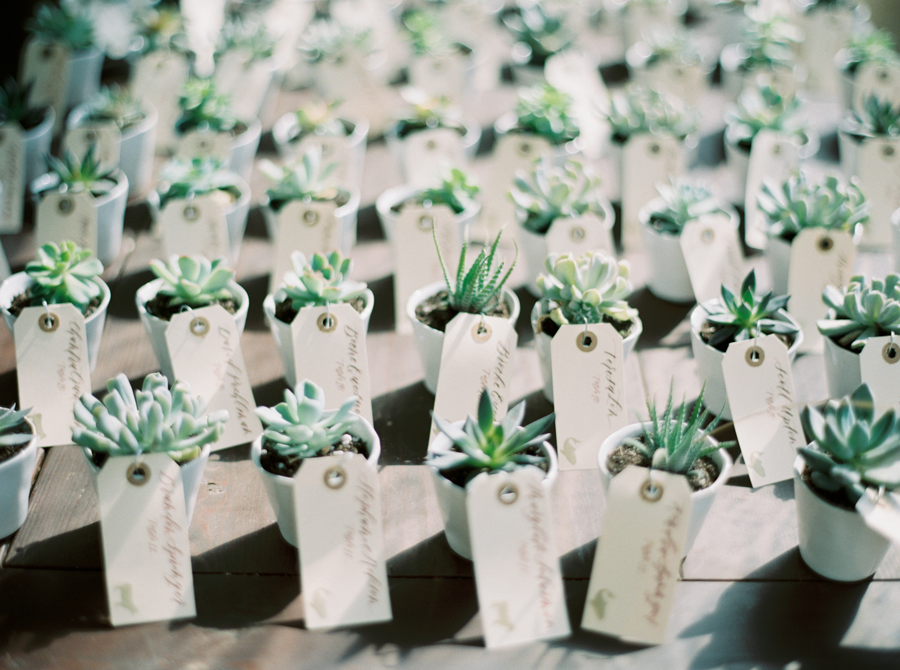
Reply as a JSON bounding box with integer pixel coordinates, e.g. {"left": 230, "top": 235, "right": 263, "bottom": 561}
{"left": 690, "top": 270, "right": 803, "bottom": 420}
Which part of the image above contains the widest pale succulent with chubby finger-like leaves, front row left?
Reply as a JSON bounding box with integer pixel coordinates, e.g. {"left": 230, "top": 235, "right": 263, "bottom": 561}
{"left": 72, "top": 372, "right": 228, "bottom": 463}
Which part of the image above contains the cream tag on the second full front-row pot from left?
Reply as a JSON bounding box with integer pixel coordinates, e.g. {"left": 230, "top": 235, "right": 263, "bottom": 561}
{"left": 294, "top": 454, "right": 392, "bottom": 629}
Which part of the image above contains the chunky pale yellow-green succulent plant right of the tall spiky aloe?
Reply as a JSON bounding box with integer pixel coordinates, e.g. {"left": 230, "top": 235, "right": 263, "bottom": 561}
{"left": 537, "top": 251, "right": 638, "bottom": 326}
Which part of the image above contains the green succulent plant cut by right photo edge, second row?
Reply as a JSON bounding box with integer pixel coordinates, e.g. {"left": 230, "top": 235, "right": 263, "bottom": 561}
{"left": 818, "top": 274, "right": 900, "bottom": 352}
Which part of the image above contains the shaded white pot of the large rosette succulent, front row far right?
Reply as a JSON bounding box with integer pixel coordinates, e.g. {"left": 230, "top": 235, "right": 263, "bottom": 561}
{"left": 794, "top": 456, "right": 891, "bottom": 582}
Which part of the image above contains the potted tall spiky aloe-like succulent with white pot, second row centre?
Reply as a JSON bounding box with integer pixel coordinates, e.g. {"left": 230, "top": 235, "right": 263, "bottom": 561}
{"left": 406, "top": 231, "right": 520, "bottom": 393}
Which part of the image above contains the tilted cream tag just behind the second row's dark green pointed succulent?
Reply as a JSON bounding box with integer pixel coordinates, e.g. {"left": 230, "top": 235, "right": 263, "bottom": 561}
{"left": 679, "top": 213, "right": 744, "bottom": 303}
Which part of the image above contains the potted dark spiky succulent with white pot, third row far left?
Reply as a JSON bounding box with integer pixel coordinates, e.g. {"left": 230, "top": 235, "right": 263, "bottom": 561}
{"left": 31, "top": 145, "right": 128, "bottom": 265}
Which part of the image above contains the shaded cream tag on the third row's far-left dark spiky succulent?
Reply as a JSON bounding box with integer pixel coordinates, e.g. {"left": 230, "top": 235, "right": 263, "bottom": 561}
{"left": 34, "top": 191, "right": 97, "bottom": 256}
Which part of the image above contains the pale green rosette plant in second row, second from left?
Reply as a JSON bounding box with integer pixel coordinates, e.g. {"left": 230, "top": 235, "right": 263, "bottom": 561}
{"left": 150, "top": 255, "right": 234, "bottom": 307}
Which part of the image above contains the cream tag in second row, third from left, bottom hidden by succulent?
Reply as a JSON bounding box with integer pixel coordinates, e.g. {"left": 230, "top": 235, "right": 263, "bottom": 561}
{"left": 291, "top": 303, "right": 372, "bottom": 423}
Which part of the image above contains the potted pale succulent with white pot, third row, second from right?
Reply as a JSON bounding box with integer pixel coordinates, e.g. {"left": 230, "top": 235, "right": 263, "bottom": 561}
{"left": 638, "top": 178, "right": 739, "bottom": 303}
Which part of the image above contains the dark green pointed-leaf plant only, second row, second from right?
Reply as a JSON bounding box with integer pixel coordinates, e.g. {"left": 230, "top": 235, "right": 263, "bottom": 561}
{"left": 703, "top": 270, "right": 800, "bottom": 351}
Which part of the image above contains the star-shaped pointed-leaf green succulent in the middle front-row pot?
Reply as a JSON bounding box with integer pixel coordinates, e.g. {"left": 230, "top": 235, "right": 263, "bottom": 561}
{"left": 426, "top": 389, "right": 554, "bottom": 483}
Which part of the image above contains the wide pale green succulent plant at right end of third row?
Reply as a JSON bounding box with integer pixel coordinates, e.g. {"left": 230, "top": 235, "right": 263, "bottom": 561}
{"left": 757, "top": 172, "right": 869, "bottom": 241}
